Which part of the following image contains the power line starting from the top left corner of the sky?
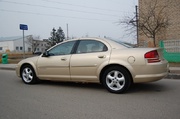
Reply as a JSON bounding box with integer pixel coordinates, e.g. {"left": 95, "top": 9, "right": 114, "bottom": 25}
{"left": 0, "top": 1, "right": 122, "bottom": 18}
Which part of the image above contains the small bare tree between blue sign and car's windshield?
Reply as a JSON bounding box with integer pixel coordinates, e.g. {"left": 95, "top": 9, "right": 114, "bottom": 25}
{"left": 26, "top": 35, "right": 39, "bottom": 53}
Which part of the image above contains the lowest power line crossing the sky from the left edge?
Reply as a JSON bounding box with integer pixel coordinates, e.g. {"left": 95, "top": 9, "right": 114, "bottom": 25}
{"left": 0, "top": 9, "right": 114, "bottom": 22}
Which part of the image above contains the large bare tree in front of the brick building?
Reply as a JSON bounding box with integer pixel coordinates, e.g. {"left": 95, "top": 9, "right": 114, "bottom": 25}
{"left": 119, "top": 0, "right": 170, "bottom": 47}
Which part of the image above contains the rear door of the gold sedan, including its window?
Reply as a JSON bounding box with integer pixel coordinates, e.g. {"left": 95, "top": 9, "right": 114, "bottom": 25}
{"left": 70, "top": 40, "right": 110, "bottom": 82}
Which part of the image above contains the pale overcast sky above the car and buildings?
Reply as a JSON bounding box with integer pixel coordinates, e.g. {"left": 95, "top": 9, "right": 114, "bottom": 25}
{"left": 0, "top": 0, "right": 138, "bottom": 43}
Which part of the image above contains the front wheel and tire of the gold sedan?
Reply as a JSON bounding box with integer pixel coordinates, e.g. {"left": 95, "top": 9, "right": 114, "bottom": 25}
{"left": 21, "top": 65, "right": 38, "bottom": 84}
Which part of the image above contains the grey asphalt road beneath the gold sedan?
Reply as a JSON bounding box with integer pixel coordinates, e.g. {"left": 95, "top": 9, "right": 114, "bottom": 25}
{"left": 0, "top": 70, "right": 180, "bottom": 119}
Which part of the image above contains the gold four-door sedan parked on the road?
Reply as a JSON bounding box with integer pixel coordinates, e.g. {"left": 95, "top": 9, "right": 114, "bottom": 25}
{"left": 16, "top": 38, "right": 169, "bottom": 93}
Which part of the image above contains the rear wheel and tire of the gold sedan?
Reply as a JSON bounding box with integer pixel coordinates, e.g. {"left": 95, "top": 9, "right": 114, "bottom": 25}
{"left": 102, "top": 66, "right": 132, "bottom": 93}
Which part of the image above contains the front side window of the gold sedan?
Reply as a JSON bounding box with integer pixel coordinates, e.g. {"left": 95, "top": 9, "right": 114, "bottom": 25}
{"left": 49, "top": 41, "right": 75, "bottom": 56}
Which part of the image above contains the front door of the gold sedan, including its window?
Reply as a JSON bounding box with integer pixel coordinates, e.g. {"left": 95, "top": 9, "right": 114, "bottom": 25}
{"left": 37, "top": 41, "right": 75, "bottom": 80}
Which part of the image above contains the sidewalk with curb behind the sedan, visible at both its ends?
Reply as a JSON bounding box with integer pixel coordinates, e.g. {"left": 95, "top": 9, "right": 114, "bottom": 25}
{"left": 0, "top": 64, "right": 180, "bottom": 79}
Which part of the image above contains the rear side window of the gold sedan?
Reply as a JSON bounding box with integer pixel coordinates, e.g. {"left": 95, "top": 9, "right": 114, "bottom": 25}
{"left": 76, "top": 40, "right": 108, "bottom": 54}
